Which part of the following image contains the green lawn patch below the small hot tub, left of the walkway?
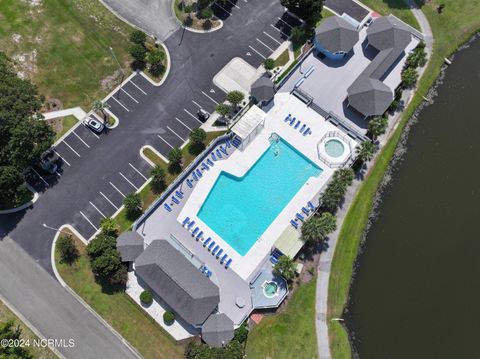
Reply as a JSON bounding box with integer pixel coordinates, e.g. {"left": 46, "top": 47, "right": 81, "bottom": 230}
{"left": 246, "top": 277, "right": 318, "bottom": 359}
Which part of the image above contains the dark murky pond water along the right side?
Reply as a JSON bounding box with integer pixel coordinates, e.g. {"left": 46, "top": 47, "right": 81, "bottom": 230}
{"left": 346, "top": 40, "right": 480, "bottom": 359}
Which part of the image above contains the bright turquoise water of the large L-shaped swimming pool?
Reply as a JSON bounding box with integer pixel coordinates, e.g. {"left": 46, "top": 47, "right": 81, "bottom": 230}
{"left": 197, "top": 139, "right": 322, "bottom": 256}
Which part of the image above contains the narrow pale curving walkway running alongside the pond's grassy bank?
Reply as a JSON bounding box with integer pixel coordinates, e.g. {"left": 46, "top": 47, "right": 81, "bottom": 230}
{"left": 315, "top": 0, "right": 433, "bottom": 359}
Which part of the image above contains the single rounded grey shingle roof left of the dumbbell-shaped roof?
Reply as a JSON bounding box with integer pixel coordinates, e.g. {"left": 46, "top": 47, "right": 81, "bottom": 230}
{"left": 315, "top": 16, "right": 358, "bottom": 53}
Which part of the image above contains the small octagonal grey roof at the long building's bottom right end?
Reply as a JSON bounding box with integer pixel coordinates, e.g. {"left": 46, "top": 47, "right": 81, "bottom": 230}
{"left": 202, "top": 313, "right": 234, "bottom": 348}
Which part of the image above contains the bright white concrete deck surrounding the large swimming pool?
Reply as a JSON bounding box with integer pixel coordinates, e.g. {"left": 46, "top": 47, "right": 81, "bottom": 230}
{"left": 177, "top": 93, "right": 357, "bottom": 280}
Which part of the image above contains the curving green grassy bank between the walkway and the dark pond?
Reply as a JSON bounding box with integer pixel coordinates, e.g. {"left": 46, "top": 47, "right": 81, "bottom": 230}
{"left": 328, "top": 0, "right": 480, "bottom": 359}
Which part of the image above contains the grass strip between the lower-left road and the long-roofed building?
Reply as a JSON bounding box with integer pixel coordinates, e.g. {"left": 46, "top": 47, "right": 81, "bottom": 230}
{"left": 55, "top": 233, "right": 183, "bottom": 359}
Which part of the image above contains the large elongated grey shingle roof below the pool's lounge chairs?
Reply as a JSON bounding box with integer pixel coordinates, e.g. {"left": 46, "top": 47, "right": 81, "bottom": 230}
{"left": 135, "top": 240, "right": 220, "bottom": 325}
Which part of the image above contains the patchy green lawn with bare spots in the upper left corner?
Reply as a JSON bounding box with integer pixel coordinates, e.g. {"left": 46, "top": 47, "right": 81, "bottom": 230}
{"left": 0, "top": 0, "right": 131, "bottom": 109}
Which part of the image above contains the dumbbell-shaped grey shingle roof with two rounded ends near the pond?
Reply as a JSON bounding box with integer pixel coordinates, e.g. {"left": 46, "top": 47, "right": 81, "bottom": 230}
{"left": 347, "top": 16, "right": 412, "bottom": 116}
